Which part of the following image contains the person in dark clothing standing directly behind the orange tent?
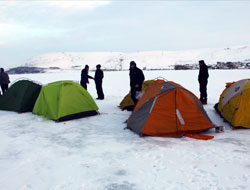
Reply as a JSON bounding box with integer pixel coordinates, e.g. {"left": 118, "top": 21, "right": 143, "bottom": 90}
{"left": 129, "top": 61, "right": 145, "bottom": 105}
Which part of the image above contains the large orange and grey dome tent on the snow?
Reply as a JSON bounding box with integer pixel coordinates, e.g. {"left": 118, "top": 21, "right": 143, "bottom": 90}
{"left": 127, "top": 81, "right": 214, "bottom": 137}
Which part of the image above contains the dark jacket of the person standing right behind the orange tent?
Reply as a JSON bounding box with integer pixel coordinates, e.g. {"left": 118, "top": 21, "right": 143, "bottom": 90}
{"left": 129, "top": 67, "right": 145, "bottom": 88}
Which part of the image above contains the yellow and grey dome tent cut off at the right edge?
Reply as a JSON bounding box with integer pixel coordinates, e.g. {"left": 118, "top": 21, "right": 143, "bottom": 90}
{"left": 214, "top": 79, "right": 250, "bottom": 128}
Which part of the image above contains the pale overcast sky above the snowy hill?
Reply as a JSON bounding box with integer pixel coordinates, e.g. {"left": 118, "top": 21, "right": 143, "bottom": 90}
{"left": 0, "top": 0, "right": 250, "bottom": 67}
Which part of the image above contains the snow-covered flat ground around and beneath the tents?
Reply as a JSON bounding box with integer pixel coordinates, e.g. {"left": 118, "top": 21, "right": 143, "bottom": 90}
{"left": 0, "top": 70, "right": 250, "bottom": 190}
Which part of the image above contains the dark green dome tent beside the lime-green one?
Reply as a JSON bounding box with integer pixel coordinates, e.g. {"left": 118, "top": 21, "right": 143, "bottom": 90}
{"left": 0, "top": 80, "right": 41, "bottom": 113}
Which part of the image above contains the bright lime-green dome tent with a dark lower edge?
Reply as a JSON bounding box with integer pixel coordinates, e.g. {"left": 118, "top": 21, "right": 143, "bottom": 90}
{"left": 33, "top": 81, "right": 98, "bottom": 121}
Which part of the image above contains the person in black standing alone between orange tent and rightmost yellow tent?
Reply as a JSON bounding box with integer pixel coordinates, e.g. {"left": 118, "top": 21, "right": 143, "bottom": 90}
{"left": 198, "top": 60, "right": 209, "bottom": 104}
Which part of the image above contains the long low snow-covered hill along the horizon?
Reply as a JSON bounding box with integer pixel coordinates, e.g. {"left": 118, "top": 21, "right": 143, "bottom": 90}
{"left": 24, "top": 46, "right": 250, "bottom": 70}
